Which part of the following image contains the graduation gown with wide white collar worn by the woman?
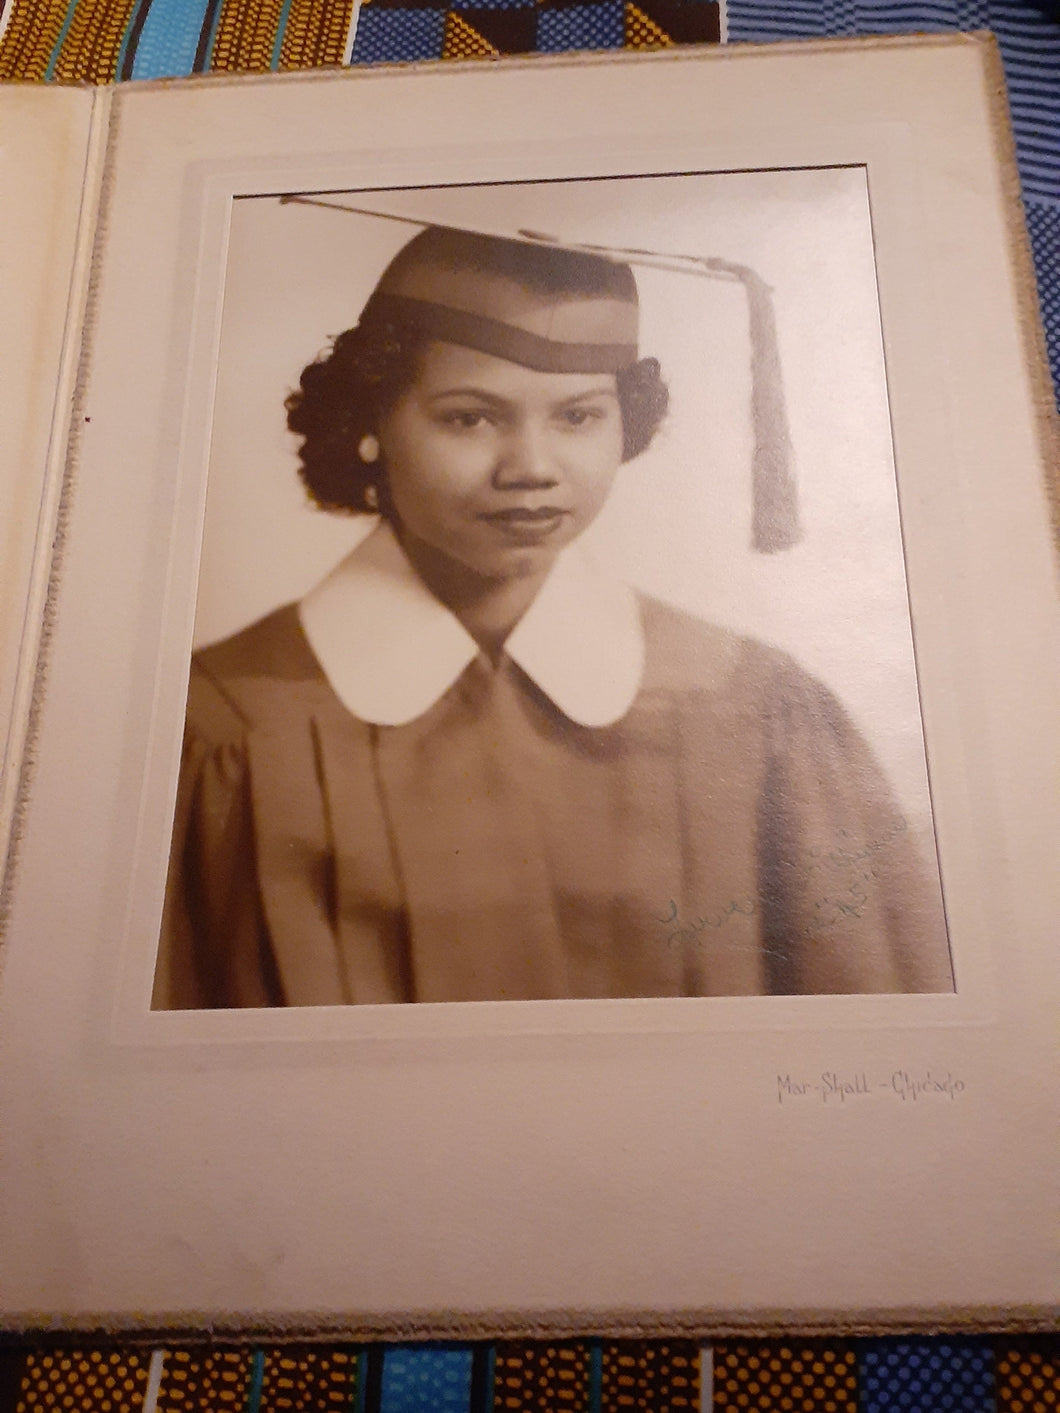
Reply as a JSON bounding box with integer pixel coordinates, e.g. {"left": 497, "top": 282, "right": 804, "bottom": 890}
{"left": 153, "top": 531, "right": 953, "bottom": 1009}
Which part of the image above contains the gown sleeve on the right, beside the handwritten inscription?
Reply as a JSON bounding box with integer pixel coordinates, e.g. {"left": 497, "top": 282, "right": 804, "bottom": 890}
{"left": 758, "top": 649, "right": 953, "bottom": 995}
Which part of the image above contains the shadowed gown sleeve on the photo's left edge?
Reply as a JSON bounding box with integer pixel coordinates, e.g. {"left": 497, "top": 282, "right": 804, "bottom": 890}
{"left": 151, "top": 664, "right": 283, "bottom": 1010}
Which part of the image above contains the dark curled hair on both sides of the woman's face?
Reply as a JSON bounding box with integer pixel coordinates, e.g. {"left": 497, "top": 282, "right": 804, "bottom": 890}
{"left": 285, "top": 322, "right": 670, "bottom": 514}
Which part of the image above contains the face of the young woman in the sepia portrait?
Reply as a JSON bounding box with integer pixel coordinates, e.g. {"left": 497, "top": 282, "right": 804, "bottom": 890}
{"left": 379, "top": 343, "right": 622, "bottom": 579}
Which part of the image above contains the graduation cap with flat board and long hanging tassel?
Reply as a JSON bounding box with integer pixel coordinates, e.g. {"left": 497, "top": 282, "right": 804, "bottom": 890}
{"left": 281, "top": 196, "right": 801, "bottom": 554}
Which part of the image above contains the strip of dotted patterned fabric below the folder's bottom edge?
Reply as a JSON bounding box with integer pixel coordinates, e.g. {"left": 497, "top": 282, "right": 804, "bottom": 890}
{"left": 0, "top": 1335, "right": 1060, "bottom": 1413}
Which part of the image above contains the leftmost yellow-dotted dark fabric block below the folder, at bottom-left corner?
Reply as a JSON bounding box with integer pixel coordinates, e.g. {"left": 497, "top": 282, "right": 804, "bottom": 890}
{"left": 16, "top": 1349, "right": 151, "bottom": 1413}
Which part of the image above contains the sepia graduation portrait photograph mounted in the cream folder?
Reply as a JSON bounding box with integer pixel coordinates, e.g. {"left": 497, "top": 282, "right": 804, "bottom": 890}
{"left": 153, "top": 167, "right": 953, "bottom": 1010}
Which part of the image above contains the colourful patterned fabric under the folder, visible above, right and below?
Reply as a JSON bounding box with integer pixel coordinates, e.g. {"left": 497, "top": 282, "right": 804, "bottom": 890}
{"left": 0, "top": 0, "right": 1060, "bottom": 1413}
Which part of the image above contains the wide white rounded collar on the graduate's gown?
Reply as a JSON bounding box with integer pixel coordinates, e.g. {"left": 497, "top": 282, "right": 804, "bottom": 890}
{"left": 298, "top": 523, "right": 644, "bottom": 726}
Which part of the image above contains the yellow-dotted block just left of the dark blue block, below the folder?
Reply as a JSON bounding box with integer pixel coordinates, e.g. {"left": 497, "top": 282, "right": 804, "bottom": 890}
{"left": 714, "top": 1341, "right": 858, "bottom": 1413}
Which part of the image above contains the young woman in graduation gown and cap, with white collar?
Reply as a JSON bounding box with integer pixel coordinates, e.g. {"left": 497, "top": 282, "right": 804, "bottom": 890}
{"left": 154, "top": 226, "right": 951, "bottom": 1007}
